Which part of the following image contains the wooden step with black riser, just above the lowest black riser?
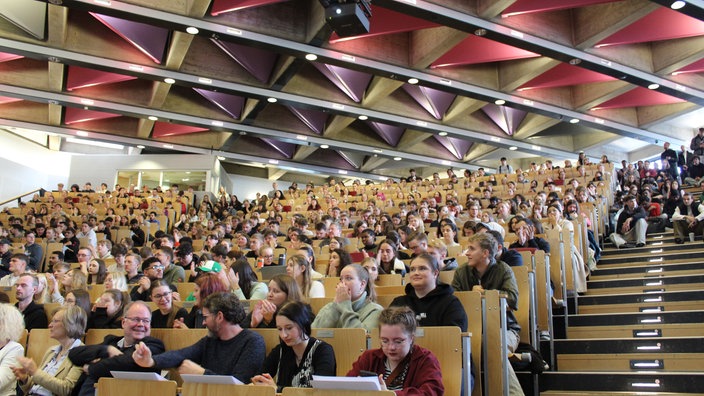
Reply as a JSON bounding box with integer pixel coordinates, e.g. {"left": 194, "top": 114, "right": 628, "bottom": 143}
{"left": 554, "top": 337, "right": 704, "bottom": 372}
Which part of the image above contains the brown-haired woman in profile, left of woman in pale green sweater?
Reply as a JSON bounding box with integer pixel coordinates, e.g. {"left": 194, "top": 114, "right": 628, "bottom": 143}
{"left": 242, "top": 274, "right": 303, "bottom": 328}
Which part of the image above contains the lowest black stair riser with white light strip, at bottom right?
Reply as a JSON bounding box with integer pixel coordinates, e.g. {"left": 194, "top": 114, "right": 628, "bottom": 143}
{"left": 539, "top": 371, "right": 704, "bottom": 395}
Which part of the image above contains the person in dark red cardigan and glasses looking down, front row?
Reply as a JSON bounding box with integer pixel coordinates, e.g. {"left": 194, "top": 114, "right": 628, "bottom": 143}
{"left": 347, "top": 307, "right": 445, "bottom": 396}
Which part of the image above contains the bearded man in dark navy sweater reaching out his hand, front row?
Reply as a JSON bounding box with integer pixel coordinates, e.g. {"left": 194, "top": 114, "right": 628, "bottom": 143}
{"left": 132, "top": 292, "right": 265, "bottom": 383}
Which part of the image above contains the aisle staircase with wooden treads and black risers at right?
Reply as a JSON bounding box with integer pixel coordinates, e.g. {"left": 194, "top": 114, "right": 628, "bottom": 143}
{"left": 524, "top": 233, "right": 704, "bottom": 395}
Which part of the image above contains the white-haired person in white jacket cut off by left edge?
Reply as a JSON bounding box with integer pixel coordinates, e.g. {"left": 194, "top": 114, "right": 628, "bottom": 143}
{"left": 0, "top": 304, "right": 24, "bottom": 396}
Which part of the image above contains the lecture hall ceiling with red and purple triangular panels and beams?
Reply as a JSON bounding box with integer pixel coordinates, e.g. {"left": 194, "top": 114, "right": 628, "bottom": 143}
{"left": 0, "top": 0, "right": 704, "bottom": 178}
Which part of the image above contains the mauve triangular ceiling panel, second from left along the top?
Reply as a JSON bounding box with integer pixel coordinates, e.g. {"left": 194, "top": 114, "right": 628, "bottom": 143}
{"left": 90, "top": 12, "right": 169, "bottom": 64}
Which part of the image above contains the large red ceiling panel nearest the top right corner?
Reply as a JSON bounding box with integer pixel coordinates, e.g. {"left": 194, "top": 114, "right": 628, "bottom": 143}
{"left": 596, "top": 7, "right": 704, "bottom": 47}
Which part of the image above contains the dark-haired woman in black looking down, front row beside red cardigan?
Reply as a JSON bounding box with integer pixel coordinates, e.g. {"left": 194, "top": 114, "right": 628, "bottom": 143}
{"left": 252, "top": 301, "right": 337, "bottom": 392}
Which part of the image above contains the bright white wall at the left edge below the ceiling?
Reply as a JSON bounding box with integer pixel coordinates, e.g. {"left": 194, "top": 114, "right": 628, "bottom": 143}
{"left": 0, "top": 131, "right": 71, "bottom": 205}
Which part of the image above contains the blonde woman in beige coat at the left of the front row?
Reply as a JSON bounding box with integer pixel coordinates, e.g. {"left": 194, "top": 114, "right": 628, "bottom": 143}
{"left": 13, "top": 305, "right": 87, "bottom": 396}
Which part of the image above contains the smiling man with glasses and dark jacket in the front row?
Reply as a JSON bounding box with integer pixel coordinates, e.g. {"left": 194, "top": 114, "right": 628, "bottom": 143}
{"left": 68, "top": 301, "right": 165, "bottom": 396}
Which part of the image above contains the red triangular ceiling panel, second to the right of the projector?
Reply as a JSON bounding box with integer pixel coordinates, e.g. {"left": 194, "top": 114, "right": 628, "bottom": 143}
{"left": 430, "top": 35, "right": 540, "bottom": 68}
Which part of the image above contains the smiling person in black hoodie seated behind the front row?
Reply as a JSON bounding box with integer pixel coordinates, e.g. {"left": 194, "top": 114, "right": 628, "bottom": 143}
{"left": 390, "top": 253, "right": 467, "bottom": 331}
